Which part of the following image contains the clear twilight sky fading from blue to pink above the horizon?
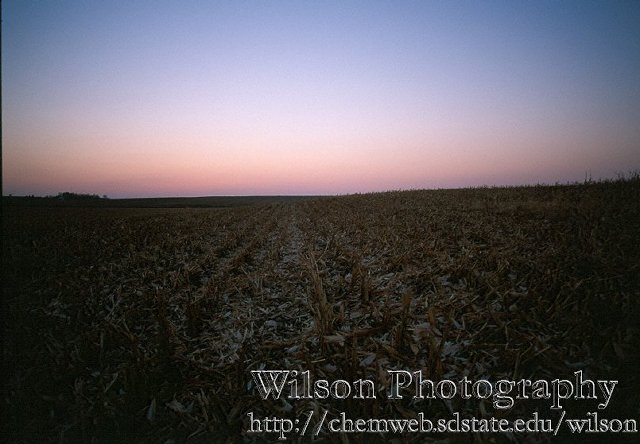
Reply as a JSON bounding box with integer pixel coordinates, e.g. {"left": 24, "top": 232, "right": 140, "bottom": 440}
{"left": 2, "top": 0, "right": 640, "bottom": 197}
